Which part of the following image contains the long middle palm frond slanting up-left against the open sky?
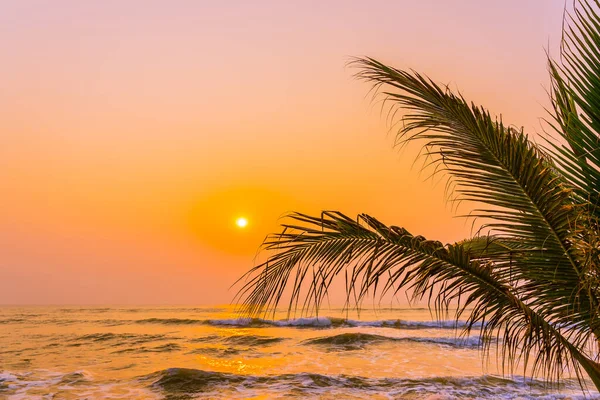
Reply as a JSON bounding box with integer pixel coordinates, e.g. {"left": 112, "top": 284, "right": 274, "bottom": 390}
{"left": 354, "top": 58, "right": 600, "bottom": 337}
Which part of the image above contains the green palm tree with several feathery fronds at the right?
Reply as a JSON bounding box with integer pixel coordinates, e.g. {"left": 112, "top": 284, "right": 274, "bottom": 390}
{"left": 238, "top": 0, "right": 600, "bottom": 390}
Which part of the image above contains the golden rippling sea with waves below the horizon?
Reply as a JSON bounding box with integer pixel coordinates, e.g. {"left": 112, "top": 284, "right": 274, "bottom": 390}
{"left": 0, "top": 306, "right": 600, "bottom": 400}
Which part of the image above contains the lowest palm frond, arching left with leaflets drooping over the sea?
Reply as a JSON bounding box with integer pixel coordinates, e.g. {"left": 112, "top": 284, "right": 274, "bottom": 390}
{"left": 233, "top": 212, "right": 600, "bottom": 383}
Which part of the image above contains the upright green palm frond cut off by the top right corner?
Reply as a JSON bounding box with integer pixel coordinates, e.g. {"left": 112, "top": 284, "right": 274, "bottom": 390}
{"left": 549, "top": 1, "right": 600, "bottom": 219}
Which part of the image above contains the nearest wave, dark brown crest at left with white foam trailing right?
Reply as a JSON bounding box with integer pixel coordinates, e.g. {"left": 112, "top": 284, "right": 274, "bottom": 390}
{"left": 139, "top": 368, "right": 600, "bottom": 399}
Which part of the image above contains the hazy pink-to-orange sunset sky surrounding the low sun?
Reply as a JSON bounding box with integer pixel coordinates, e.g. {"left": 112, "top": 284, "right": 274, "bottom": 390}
{"left": 0, "top": 0, "right": 565, "bottom": 304}
